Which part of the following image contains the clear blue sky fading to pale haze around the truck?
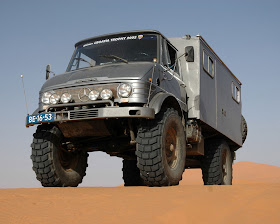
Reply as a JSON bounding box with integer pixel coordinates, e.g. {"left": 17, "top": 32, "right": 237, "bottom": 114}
{"left": 0, "top": 0, "right": 280, "bottom": 188}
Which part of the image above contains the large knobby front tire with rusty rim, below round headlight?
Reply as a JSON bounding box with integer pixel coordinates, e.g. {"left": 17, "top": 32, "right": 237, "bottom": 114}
{"left": 136, "top": 108, "right": 186, "bottom": 186}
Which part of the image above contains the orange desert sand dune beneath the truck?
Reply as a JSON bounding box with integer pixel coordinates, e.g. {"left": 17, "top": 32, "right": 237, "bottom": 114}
{"left": 0, "top": 162, "right": 280, "bottom": 224}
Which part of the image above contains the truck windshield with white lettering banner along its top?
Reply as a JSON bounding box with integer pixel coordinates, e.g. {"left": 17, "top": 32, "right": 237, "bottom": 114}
{"left": 67, "top": 34, "right": 157, "bottom": 71}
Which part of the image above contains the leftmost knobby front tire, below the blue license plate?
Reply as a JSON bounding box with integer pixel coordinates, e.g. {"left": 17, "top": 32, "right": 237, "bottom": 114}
{"left": 31, "top": 125, "right": 88, "bottom": 187}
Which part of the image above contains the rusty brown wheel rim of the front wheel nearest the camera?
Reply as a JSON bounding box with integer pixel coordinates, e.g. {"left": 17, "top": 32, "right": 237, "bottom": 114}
{"left": 164, "top": 123, "right": 178, "bottom": 169}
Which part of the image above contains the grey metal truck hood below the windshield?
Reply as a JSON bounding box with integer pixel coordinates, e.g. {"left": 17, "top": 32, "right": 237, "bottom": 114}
{"left": 42, "top": 62, "right": 154, "bottom": 90}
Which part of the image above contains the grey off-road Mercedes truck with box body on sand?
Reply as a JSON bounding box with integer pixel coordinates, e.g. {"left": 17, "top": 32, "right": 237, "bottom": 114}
{"left": 26, "top": 30, "right": 247, "bottom": 187}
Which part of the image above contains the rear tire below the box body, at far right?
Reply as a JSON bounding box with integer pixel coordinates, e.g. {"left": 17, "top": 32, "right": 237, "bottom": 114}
{"left": 201, "top": 140, "right": 233, "bottom": 185}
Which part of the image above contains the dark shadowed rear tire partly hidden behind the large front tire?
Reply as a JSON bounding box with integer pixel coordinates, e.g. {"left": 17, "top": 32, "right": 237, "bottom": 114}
{"left": 122, "top": 159, "right": 145, "bottom": 186}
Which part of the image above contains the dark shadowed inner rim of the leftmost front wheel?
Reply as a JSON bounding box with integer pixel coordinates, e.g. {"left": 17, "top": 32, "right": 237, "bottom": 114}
{"left": 58, "top": 147, "right": 79, "bottom": 171}
